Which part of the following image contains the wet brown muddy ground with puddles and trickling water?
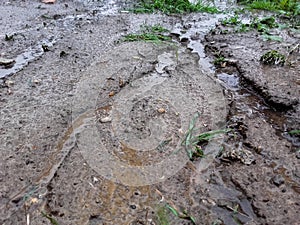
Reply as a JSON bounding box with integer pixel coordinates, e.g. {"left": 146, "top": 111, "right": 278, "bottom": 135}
{"left": 0, "top": 0, "right": 300, "bottom": 225}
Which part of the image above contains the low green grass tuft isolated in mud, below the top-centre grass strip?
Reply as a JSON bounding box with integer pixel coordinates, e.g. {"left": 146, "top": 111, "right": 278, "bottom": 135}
{"left": 121, "top": 24, "right": 172, "bottom": 43}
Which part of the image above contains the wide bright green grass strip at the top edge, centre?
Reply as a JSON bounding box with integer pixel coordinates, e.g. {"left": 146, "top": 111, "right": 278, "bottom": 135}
{"left": 133, "top": 0, "right": 220, "bottom": 14}
